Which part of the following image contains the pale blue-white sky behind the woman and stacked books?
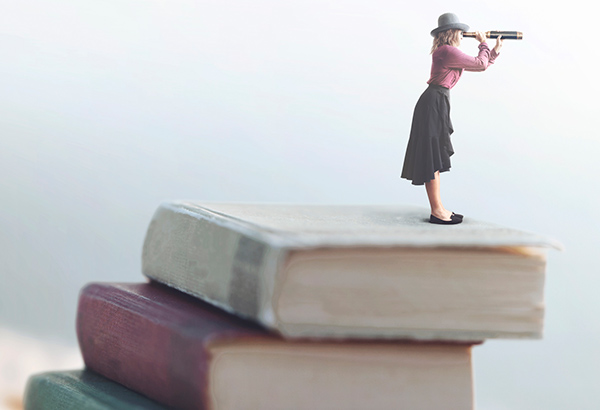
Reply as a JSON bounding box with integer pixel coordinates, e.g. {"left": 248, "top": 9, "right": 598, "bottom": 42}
{"left": 0, "top": 0, "right": 600, "bottom": 410}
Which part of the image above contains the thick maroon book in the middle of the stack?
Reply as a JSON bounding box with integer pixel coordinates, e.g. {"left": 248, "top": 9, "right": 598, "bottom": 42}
{"left": 77, "top": 282, "right": 473, "bottom": 410}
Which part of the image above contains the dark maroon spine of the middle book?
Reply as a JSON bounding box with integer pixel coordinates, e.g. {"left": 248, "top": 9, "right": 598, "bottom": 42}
{"left": 77, "top": 284, "right": 208, "bottom": 409}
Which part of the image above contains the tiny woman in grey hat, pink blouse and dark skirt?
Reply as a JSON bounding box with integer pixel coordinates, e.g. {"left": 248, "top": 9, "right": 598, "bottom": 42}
{"left": 401, "top": 13, "right": 503, "bottom": 225}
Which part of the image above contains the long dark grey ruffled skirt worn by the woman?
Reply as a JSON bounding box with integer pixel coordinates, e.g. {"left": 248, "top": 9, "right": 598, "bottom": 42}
{"left": 401, "top": 85, "right": 454, "bottom": 185}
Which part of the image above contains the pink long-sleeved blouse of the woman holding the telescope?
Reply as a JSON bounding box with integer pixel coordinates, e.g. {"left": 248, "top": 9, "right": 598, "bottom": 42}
{"left": 427, "top": 43, "right": 498, "bottom": 88}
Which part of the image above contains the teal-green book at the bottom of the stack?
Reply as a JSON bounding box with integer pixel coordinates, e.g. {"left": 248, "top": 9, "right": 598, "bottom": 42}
{"left": 24, "top": 370, "right": 167, "bottom": 410}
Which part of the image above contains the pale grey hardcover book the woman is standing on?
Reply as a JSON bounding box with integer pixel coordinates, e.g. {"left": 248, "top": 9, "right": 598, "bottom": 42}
{"left": 142, "top": 202, "right": 560, "bottom": 341}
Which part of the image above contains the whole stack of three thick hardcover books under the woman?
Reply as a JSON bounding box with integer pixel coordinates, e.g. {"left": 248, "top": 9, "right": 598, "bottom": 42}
{"left": 25, "top": 202, "right": 559, "bottom": 409}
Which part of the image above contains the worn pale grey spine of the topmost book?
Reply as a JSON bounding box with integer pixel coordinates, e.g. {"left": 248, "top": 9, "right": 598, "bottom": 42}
{"left": 142, "top": 203, "right": 287, "bottom": 328}
